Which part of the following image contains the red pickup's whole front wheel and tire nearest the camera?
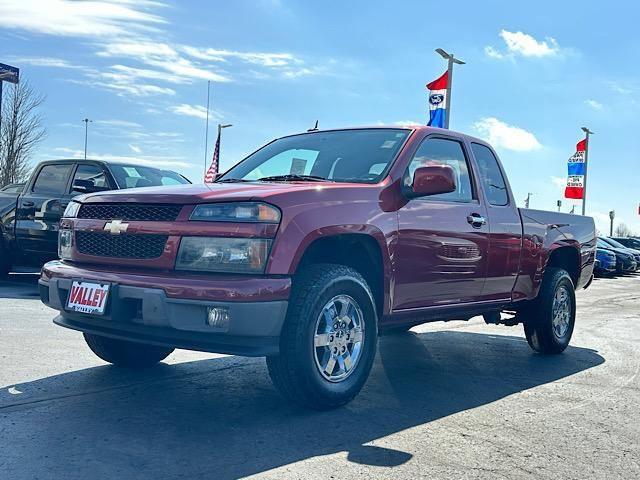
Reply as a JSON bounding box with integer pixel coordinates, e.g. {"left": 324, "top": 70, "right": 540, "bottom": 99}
{"left": 267, "top": 264, "right": 378, "bottom": 410}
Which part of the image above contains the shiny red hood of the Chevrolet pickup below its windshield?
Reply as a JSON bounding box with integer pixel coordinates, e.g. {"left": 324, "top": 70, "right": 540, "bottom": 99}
{"left": 76, "top": 182, "right": 372, "bottom": 205}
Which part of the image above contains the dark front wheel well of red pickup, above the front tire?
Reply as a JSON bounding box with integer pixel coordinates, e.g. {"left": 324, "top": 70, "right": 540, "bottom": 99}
{"left": 296, "top": 233, "right": 384, "bottom": 315}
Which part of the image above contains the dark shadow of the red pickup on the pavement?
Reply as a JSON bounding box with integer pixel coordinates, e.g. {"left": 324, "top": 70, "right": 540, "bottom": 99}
{"left": 0, "top": 331, "right": 605, "bottom": 479}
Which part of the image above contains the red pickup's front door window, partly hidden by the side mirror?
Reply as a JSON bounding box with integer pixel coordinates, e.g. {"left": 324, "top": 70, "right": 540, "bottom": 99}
{"left": 405, "top": 138, "right": 473, "bottom": 202}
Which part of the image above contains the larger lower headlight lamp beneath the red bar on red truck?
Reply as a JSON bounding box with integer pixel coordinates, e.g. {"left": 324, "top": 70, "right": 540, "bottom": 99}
{"left": 176, "top": 237, "right": 271, "bottom": 273}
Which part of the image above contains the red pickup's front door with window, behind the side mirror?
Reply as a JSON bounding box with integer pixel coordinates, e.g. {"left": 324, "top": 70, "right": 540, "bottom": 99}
{"left": 394, "top": 135, "right": 489, "bottom": 310}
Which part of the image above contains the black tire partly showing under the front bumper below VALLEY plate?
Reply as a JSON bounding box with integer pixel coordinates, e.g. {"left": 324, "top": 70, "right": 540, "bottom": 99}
{"left": 84, "top": 333, "right": 173, "bottom": 368}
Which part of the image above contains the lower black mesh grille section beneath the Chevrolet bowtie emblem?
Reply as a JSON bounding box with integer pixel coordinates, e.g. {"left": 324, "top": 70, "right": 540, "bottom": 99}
{"left": 76, "top": 231, "right": 169, "bottom": 259}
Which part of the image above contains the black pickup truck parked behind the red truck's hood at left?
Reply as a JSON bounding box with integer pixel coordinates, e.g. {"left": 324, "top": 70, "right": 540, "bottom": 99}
{"left": 0, "top": 160, "right": 189, "bottom": 275}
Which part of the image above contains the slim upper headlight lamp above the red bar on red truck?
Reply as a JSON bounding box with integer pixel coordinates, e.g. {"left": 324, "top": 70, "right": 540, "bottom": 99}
{"left": 190, "top": 202, "right": 280, "bottom": 223}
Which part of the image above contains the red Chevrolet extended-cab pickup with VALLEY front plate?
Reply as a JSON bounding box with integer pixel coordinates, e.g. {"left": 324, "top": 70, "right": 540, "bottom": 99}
{"left": 39, "top": 127, "right": 596, "bottom": 409}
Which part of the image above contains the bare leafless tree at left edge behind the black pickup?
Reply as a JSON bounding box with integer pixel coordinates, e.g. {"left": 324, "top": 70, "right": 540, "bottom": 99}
{"left": 0, "top": 81, "right": 46, "bottom": 187}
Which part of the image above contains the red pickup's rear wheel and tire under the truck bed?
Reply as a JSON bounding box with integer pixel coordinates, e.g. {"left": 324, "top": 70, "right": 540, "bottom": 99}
{"left": 523, "top": 267, "right": 576, "bottom": 354}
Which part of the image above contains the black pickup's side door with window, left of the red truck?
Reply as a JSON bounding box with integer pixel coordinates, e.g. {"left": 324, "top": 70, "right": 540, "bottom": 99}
{"left": 16, "top": 162, "right": 74, "bottom": 258}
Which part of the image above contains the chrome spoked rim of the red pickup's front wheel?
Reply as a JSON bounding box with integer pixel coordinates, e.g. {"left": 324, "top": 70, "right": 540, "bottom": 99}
{"left": 313, "top": 295, "right": 364, "bottom": 382}
